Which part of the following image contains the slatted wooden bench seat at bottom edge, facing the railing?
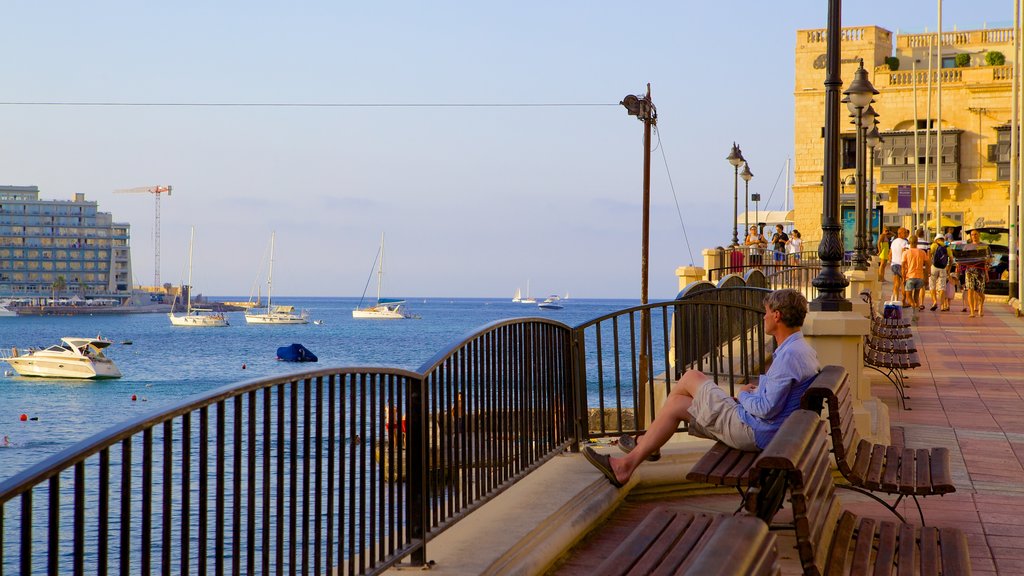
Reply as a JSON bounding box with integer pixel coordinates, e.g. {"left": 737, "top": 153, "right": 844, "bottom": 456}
{"left": 597, "top": 506, "right": 781, "bottom": 576}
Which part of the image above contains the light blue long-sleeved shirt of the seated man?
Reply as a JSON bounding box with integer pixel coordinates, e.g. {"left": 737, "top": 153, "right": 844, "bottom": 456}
{"left": 738, "top": 331, "right": 821, "bottom": 450}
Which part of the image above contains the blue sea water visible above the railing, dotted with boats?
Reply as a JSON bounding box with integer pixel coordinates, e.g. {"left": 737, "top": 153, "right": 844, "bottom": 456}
{"left": 0, "top": 296, "right": 639, "bottom": 481}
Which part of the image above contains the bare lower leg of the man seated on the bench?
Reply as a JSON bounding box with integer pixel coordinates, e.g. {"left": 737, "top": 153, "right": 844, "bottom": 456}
{"left": 609, "top": 370, "right": 709, "bottom": 484}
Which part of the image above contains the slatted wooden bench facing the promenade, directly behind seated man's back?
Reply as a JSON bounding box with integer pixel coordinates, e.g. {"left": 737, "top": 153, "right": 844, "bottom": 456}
{"left": 801, "top": 366, "right": 956, "bottom": 525}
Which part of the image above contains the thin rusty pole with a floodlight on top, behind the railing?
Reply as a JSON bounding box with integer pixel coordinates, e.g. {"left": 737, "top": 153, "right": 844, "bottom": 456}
{"left": 620, "top": 82, "right": 657, "bottom": 418}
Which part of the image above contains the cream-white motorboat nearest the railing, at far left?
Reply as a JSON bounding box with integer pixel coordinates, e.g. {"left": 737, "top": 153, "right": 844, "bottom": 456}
{"left": 2, "top": 337, "right": 121, "bottom": 379}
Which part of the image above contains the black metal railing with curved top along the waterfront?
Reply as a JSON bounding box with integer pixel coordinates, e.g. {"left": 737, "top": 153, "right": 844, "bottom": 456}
{"left": 0, "top": 286, "right": 767, "bottom": 576}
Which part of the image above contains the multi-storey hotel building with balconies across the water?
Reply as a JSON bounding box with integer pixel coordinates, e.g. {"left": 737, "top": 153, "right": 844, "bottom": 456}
{"left": 0, "top": 186, "right": 132, "bottom": 303}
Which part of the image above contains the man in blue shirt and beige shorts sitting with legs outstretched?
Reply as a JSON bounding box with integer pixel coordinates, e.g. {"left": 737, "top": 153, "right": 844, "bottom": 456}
{"left": 583, "top": 288, "right": 820, "bottom": 487}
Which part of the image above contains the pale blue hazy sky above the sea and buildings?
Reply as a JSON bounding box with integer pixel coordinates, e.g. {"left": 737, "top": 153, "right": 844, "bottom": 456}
{"left": 0, "top": 0, "right": 1013, "bottom": 299}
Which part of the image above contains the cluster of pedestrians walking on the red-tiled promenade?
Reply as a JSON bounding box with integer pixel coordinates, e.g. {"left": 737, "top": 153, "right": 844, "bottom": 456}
{"left": 879, "top": 227, "right": 987, "bottom": 318}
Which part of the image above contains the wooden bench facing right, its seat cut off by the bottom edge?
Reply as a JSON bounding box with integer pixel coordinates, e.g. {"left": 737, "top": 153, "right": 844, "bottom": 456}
{"left": 749, "top": 410, "right": 971, "bottom": 576}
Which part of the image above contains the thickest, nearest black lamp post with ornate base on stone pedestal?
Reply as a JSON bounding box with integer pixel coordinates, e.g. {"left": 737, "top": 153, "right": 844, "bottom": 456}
{"left": 810, "top": 0, "right": 853, "bottom": 312}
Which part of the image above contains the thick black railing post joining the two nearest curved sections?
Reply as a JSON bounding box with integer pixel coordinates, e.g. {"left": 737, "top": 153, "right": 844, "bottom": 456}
{"left": 406, "top": 376, "right": 430, "bottom": 566}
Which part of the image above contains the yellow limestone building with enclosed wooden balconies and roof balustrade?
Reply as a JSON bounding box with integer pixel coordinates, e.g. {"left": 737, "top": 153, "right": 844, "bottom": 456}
{"left": 794, "top": 26, "right": 1014, "bottom": 241}
